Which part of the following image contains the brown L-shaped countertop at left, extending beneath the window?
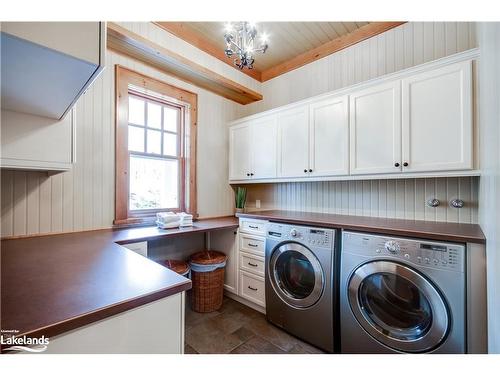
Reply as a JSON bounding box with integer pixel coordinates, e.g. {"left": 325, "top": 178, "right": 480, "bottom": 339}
{"left": 1, "top": 217, "right": 238, "bottom": 337}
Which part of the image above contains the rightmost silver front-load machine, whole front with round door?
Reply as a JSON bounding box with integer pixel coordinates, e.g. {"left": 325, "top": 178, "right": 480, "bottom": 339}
{"left": 340, "top": 232, "right": 466, "bottom": 354}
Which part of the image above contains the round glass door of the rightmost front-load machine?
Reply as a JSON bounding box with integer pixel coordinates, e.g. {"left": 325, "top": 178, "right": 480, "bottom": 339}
{"left": 349, "top": 261, "right": 449, "bottom": 352}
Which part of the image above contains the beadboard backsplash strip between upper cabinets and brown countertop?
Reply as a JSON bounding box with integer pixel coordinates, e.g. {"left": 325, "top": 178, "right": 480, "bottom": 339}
{"left": 247, "top": 177, "right": 479, "bottom": 223}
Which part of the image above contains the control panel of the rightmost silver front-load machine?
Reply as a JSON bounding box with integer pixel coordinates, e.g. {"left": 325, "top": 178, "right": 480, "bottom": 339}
{"left": 342, "top": 232, "right": 465, "bottom": 272}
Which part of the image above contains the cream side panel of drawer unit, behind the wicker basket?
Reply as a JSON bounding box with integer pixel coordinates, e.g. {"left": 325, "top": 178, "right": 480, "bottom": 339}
{"left": 210, "top": 229, "right": 238, "bottom": 294}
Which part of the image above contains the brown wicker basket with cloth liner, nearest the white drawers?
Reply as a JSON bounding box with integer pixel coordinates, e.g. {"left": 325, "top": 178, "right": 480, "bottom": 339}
{"left": 189, "top": 251, "right": 227, "bottom": 312}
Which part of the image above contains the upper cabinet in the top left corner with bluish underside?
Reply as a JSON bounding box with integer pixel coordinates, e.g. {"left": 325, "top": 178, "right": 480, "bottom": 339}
{"left": 1, "top": 22, "right": 106, "bottom": 120}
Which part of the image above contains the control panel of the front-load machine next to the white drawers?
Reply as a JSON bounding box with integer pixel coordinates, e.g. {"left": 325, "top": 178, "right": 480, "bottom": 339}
{"left": 267, "top": 223, "right": 335, "bottom": 248}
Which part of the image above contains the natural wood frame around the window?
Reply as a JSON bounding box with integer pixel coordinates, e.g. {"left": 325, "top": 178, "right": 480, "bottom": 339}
{"left": 114, "top": 64, "right": 198, "bottom": 225}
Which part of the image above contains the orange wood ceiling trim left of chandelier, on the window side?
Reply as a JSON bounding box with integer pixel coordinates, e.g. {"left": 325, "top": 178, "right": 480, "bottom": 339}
{"left": 153, "top": 21, "right": 261, "bottom": 82}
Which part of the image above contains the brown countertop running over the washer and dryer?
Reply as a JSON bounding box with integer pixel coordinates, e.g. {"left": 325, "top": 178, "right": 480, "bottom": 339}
{"left": 237, "top": 210, "right": 486, "bottom": 244}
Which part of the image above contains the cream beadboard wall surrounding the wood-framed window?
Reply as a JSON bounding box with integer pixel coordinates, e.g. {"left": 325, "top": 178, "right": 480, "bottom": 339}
{"left": 1, "top": 23, "right": 240, "bottom": 236}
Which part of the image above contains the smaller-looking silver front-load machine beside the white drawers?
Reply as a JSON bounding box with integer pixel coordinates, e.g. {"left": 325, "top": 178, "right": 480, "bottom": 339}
{"left": 265, "top": 223, "right": 335, "bottom": 352}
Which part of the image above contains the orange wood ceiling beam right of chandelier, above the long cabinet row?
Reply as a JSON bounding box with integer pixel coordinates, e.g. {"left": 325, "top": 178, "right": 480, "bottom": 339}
{"left": 261, "top": 22, "right": 405, "bottom": 82}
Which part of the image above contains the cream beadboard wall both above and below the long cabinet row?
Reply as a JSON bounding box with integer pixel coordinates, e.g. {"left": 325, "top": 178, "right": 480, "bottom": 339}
{"left": 239, "top": 22, "right": 478, "bottom": 223}
